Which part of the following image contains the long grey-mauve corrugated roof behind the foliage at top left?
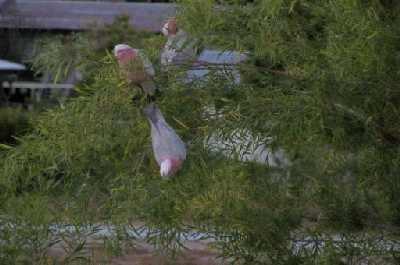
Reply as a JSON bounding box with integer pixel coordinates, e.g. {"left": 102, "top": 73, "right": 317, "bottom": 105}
{"left": 0, "top": 0, "right": 176, "bottom": 32}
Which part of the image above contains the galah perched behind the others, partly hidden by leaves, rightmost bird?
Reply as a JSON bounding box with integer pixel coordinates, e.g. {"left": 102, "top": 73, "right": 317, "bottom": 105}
{"left": 161, "top": 18, "right": 196, "bottom": 66}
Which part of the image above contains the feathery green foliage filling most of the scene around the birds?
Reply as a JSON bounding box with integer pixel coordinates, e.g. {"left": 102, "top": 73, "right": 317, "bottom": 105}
{"left": 0, "top": 0, "right": 400, "bottom": 264}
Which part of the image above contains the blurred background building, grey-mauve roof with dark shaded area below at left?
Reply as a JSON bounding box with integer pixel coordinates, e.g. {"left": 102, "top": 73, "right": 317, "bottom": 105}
{"left": 0, "top": 0, "right": 176, "bottom": 106}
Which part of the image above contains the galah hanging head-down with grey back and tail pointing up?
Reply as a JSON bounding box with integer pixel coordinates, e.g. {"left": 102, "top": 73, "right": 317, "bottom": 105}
{"left": 144, "top": 103, "right": 186, "bottom": 177}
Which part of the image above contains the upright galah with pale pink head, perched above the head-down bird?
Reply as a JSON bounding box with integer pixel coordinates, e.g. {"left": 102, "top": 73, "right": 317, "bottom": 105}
{"left": 114, "top": 44, "right": 156, "bottom": 96}
